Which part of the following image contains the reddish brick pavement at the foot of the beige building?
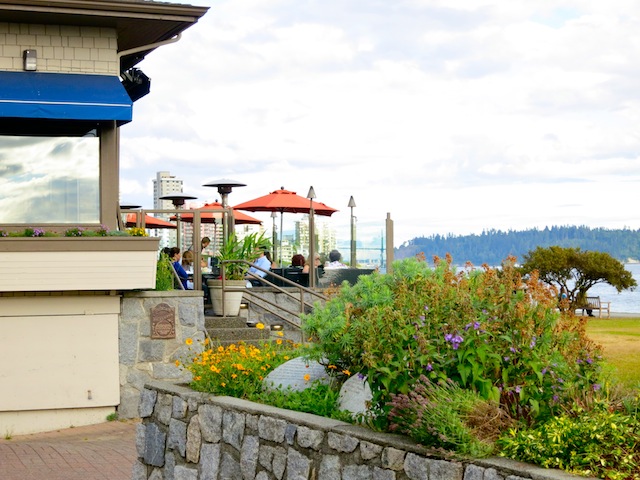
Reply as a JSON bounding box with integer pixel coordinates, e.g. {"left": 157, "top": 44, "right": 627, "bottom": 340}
{"left": 0, "top": 421, "right": 137, "bottom": 480}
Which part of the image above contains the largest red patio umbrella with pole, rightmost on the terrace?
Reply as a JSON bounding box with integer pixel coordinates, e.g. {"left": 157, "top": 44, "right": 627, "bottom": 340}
{"left": 233, "top": 187, "right": 338, "bottom": 265}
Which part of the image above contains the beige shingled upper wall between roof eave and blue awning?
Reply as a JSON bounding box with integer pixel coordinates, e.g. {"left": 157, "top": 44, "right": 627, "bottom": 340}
{"left": 0, "top": 22, "right": 119, "bottom": 75}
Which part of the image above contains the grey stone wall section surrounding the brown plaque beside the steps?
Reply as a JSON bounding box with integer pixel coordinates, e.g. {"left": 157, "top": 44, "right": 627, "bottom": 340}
{"left": 118, "top": 290, "right": 204, "bottom": 418}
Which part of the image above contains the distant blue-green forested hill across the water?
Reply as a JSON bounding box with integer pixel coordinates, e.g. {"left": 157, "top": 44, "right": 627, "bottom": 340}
{"left": 395, "top": 226, "right": 640, "bottom": 266}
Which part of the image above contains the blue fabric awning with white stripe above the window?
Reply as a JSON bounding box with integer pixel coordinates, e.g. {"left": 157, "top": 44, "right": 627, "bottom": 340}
{"left": 0, "top": 72, "right": 133, "bottom": 124}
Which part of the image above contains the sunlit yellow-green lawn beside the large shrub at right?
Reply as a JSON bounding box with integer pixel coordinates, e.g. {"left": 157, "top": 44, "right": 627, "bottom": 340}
{"left": 587, "top": 317, "right": 640, "bottom": 387}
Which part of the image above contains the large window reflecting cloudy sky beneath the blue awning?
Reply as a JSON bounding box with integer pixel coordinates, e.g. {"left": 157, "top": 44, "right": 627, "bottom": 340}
{"left": 0, "top": 135, "right": 100, "bottom": 225}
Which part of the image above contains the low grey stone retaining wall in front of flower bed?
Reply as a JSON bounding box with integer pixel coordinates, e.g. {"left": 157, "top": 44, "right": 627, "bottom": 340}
{"left": 132, "top": 382, "right": 582, "bottom": 480}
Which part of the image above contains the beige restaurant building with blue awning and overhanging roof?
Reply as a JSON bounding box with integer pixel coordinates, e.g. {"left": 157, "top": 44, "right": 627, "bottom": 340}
{"left": 0, "top": 0, "right": 207, "bottom": 435}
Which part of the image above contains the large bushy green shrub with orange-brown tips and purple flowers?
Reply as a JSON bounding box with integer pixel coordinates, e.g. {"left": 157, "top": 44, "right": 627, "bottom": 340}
{"left": 303, "top": 258, "right": 599, "bottom": 428}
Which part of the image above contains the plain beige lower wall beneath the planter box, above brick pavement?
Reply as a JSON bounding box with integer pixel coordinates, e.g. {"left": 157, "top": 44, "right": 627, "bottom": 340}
{"left": 0, "top": 295, "right": 120, "bottom": 434}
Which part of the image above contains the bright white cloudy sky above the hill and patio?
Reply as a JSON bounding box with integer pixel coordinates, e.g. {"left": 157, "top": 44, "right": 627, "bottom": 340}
{"left": 120, "top": 0, "right": 640, "bottom": 246}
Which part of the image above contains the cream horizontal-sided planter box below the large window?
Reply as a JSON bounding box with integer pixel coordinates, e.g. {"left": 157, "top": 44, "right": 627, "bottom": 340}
{"left": 0, "top": 237, "right": 159, "bottom": 292}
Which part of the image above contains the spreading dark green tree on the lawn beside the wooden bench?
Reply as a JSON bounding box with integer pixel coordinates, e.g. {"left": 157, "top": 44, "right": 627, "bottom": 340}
{"left": 522, "top": 246, "right": 637, "bottom": 308}
